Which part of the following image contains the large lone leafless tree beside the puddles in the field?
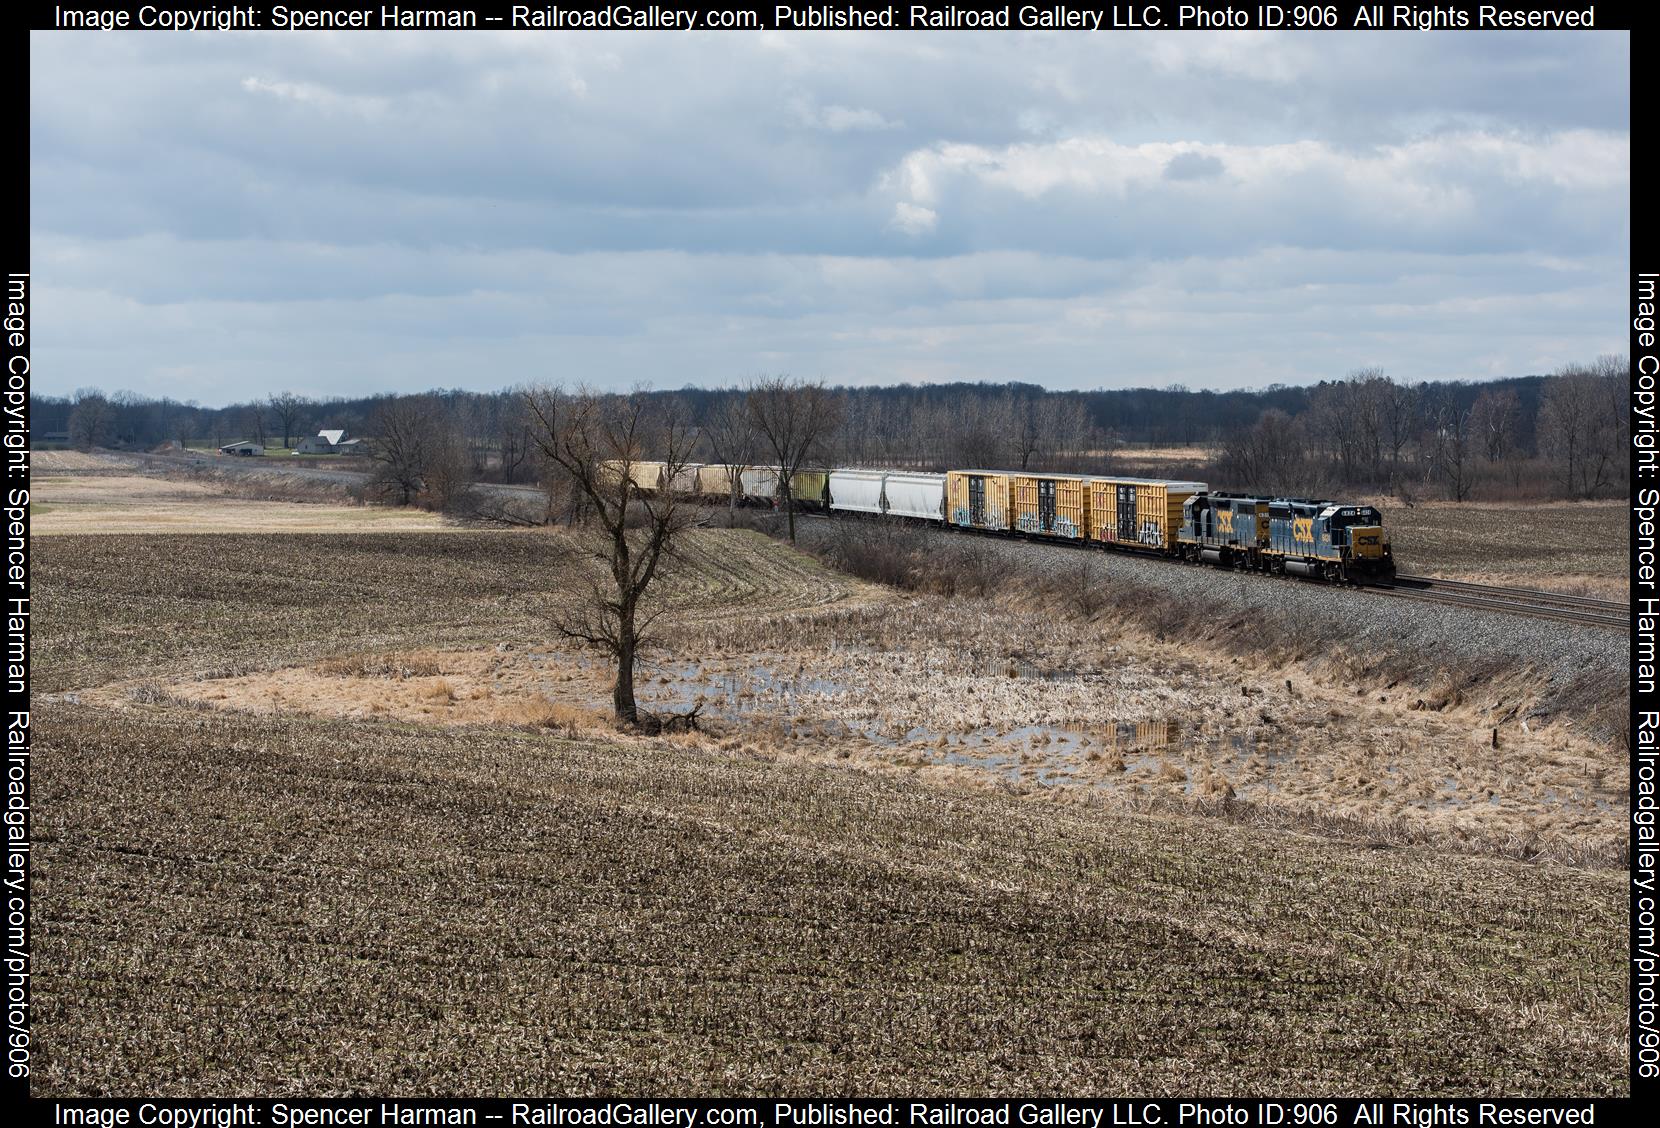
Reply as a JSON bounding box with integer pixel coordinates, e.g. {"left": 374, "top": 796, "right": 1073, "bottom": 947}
{"left": 525, "top": 388, "right": 697, "bottom": 725}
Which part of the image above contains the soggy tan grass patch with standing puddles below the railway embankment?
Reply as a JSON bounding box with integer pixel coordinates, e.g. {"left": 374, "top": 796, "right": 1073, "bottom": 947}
{"left": 126, "top": 605, "right": 1625, "bottom": 862}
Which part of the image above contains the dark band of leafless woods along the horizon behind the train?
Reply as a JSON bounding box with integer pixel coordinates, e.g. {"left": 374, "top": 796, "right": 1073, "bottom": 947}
{"left": 30, "top": 357, "right": 1630, "bottom": 509}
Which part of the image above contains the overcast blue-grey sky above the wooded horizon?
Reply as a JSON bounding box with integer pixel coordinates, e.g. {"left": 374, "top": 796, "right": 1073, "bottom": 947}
{"left": 30, "top": 32, "right": 1630, "bottom": 405}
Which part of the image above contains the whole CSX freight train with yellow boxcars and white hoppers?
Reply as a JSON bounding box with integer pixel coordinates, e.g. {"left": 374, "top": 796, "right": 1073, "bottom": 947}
{"left": 607, "top": 463, "right": 1394, "bottom": 582}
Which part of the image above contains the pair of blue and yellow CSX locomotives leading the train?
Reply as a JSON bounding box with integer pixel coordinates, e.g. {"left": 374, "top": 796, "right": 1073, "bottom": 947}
{"left": 1177, "top": 493, "right": 1394, "bottom": 582}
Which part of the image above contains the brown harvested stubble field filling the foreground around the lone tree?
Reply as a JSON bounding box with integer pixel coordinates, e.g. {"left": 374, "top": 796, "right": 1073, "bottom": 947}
{"left": 33, "top": 520, "right": 1627, "bottom": 1095}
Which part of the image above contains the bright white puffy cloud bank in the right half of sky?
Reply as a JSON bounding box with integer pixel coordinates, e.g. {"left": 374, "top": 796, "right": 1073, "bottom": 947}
{"left": 878, "top": 129, "right": 1630, "bottom": 255}
